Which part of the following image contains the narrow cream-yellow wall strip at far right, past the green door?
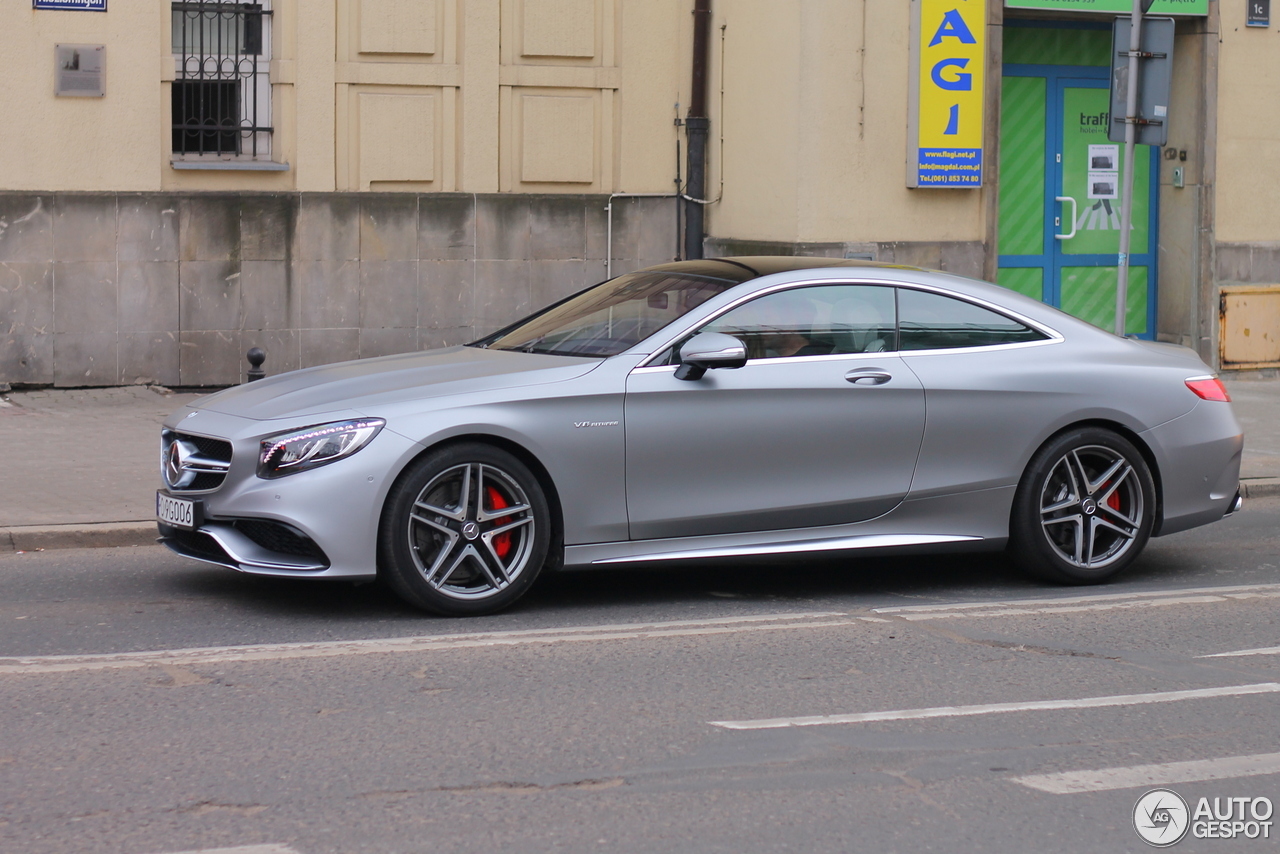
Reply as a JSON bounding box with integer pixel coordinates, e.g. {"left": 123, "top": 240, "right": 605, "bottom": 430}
{"left": 1215, "top": 0, "right": 1280, "bottom": 243}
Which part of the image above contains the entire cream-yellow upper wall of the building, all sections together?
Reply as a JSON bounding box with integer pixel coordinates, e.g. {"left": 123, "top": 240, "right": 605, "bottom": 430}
{"left": 0, "top": 0, "right": 1259, "bottom": 253}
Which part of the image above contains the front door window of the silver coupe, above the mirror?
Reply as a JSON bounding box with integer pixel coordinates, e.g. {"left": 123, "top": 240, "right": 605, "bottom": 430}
{"left": 699, "top": 284, "right": 897, "bottom": 359}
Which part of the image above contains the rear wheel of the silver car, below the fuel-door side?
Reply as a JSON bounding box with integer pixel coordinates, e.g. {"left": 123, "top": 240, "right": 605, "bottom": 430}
{"left": 1009, "top": 428, "right": 1156, "bottom": 584}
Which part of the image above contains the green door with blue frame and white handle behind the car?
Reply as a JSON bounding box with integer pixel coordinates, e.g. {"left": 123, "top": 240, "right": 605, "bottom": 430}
{"left": 997, "top": 29, "right": 1158, "bottom": 338}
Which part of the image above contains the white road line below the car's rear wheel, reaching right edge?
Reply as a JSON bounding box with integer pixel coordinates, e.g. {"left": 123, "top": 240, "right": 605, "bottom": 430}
{"left": 872, "top": 584, "right": 1280, "bottom": 621}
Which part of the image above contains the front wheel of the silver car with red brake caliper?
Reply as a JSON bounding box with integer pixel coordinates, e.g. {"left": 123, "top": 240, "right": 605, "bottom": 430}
{"left": 378, "top": 443, "right": 553, "bottom": 617}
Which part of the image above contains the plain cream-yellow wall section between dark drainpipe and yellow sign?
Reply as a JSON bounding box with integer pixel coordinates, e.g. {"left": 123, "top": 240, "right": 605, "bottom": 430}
{"left": 708, "top": 0, "right": 997, "bottom": 242}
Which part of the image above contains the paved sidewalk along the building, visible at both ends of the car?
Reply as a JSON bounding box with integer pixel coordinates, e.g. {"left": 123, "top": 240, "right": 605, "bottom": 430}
{"left": 0, "top": 379, "right": 1280, "bottom": 552}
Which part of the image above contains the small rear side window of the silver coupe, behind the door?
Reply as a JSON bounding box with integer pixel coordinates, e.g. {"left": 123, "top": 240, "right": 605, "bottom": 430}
{"left": 897, "top": 288, "right": 1044, "bottom": 350}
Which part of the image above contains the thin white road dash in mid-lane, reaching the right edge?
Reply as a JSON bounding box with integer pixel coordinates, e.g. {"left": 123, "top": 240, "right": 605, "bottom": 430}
{"left": 708, "top": 682, "right": 1280, "bottom": 730}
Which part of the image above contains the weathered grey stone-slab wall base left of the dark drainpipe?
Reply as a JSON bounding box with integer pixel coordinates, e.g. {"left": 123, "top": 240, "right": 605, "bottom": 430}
{"left": 0, "top": 193, "right": 677, "bottom": 387}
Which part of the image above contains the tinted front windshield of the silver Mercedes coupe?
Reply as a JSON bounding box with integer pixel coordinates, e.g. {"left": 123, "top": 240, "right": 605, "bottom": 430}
{"left": 472, "top": 273, "right": 737, "bottom": 356}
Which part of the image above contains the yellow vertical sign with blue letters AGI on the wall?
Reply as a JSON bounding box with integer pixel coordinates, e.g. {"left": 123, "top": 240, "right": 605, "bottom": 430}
{"left": 906, "top": 0, "right": 987, "bottom": 187}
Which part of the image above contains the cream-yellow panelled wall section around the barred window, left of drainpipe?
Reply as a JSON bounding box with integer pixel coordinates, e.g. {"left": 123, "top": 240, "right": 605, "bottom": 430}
{"left": 0, "top": 0, "right": 689, "bottom": 193}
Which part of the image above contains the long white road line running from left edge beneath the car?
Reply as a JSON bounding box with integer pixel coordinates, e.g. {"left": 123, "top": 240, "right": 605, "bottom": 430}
{"left": 0, "top": 612, "right": 858, "bottom": 675}
